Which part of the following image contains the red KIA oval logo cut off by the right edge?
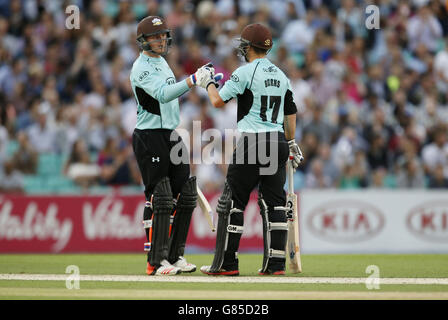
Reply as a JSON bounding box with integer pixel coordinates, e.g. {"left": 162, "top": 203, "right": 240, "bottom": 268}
{"left": 406, "top": 200, "right": 448, "bottom": 241}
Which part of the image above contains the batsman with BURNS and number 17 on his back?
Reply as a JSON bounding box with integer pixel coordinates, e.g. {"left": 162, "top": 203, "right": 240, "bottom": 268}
{"left": 201, "top": 23, "right": 303, "bottom": 276}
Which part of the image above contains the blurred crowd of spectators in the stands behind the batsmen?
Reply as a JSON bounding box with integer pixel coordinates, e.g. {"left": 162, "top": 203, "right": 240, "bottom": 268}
{"left": 0, "top": 0, "right": 448, "bottom": 193}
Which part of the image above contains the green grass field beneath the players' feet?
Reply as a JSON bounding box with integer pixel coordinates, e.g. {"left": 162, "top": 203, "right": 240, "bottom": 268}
{"left": 0, "top": 254, "right": 448, "bottom": 300}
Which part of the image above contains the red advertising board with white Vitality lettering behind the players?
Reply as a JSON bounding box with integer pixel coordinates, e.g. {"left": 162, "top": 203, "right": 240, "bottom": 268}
{"left": 0, "top": 194, "right": 263, "bottom": 253}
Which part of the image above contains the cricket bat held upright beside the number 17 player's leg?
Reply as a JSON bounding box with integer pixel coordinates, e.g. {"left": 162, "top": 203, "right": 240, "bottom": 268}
{"left": 286, "top": 160, "right": 302, "bottom": 273}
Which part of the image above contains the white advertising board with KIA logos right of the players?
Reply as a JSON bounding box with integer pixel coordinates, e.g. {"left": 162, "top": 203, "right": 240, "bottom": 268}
{"left": 298, "top": 190, "right": 448, "bottom": 253}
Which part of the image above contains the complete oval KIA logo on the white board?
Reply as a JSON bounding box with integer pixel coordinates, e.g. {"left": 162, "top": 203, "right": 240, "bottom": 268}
{"left": 306, "top": 200, "right": 384, "bottom": 242}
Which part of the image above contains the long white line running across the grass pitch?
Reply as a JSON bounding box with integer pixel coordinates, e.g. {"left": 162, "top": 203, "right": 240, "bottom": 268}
{"left": 0, "top": 274, "right": 448, "bottom": 285}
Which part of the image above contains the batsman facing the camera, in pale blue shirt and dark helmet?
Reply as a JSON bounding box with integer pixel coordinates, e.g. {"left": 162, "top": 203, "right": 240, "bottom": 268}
{"left": 130, "top": 16, "right": 222, "bottom": 275}
